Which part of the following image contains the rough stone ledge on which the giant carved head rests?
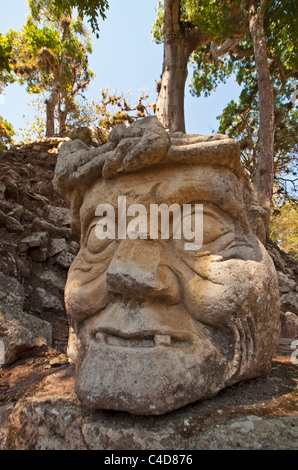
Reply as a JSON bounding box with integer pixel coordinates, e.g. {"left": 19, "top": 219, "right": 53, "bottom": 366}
{"left": 5, "top": 362, "right": 298, "bottom": 454}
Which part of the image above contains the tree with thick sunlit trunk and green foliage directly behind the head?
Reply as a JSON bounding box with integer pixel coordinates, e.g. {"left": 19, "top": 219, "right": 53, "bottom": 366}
{"left": 153, "top": 0, "right": 247, "bottom": 132}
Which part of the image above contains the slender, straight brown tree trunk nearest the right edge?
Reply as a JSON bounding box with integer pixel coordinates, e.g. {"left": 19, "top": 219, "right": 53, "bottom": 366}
{"left": 249, "top": 0, "right": 275, "bottom": 217}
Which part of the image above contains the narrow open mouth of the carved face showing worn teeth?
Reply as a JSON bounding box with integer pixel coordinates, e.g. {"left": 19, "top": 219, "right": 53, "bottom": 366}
{"left": 91, "top": 330, "right": 192, "bottom": 348}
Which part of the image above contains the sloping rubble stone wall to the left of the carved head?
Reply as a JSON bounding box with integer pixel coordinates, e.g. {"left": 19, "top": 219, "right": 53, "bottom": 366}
{"left": 0, "top": 139, "right": 79, "bottom": 364}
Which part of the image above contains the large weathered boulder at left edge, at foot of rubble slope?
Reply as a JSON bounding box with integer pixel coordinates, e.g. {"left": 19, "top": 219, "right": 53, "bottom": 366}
{"left": 0, "top": 273, "right": 52, "bottom": 364}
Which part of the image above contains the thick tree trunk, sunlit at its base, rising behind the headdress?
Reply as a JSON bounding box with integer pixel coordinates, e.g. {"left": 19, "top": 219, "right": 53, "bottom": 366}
{"left": 156, "top": 0, "right": 207, "bottom": 132}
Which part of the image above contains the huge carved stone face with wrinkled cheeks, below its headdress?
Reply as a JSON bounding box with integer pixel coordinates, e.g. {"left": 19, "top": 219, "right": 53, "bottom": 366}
{"left": 65, "top": 165, "right": 279, "bottom": 414}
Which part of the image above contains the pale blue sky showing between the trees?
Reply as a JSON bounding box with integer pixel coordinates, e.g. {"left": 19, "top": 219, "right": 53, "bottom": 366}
{"left": 0, "top": 0, "right": 240, "bottom": 141}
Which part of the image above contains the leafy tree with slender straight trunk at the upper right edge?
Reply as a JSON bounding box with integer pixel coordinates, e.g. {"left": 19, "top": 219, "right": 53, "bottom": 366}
{"left": 191, "top": 0, "right": 298, "bottom": 212}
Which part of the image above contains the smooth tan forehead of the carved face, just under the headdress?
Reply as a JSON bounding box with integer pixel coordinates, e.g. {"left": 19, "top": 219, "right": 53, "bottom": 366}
{"left": 80, "top": 165, "right": 246, "bottom": 233}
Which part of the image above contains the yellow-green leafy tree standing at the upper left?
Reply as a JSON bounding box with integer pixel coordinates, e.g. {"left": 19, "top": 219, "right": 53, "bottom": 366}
{"left": 7, "top": 0, "right": 93, "bottom": 136}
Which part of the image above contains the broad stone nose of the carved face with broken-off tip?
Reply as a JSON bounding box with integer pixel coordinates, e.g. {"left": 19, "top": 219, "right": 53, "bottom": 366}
{"left": 106, "top": 239, "right": 180, "bottom": 305}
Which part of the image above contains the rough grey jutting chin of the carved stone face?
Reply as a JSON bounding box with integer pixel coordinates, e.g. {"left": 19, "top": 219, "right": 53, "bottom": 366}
{"left": 76, "top": 335, "right": 226, "bottom": 415}
